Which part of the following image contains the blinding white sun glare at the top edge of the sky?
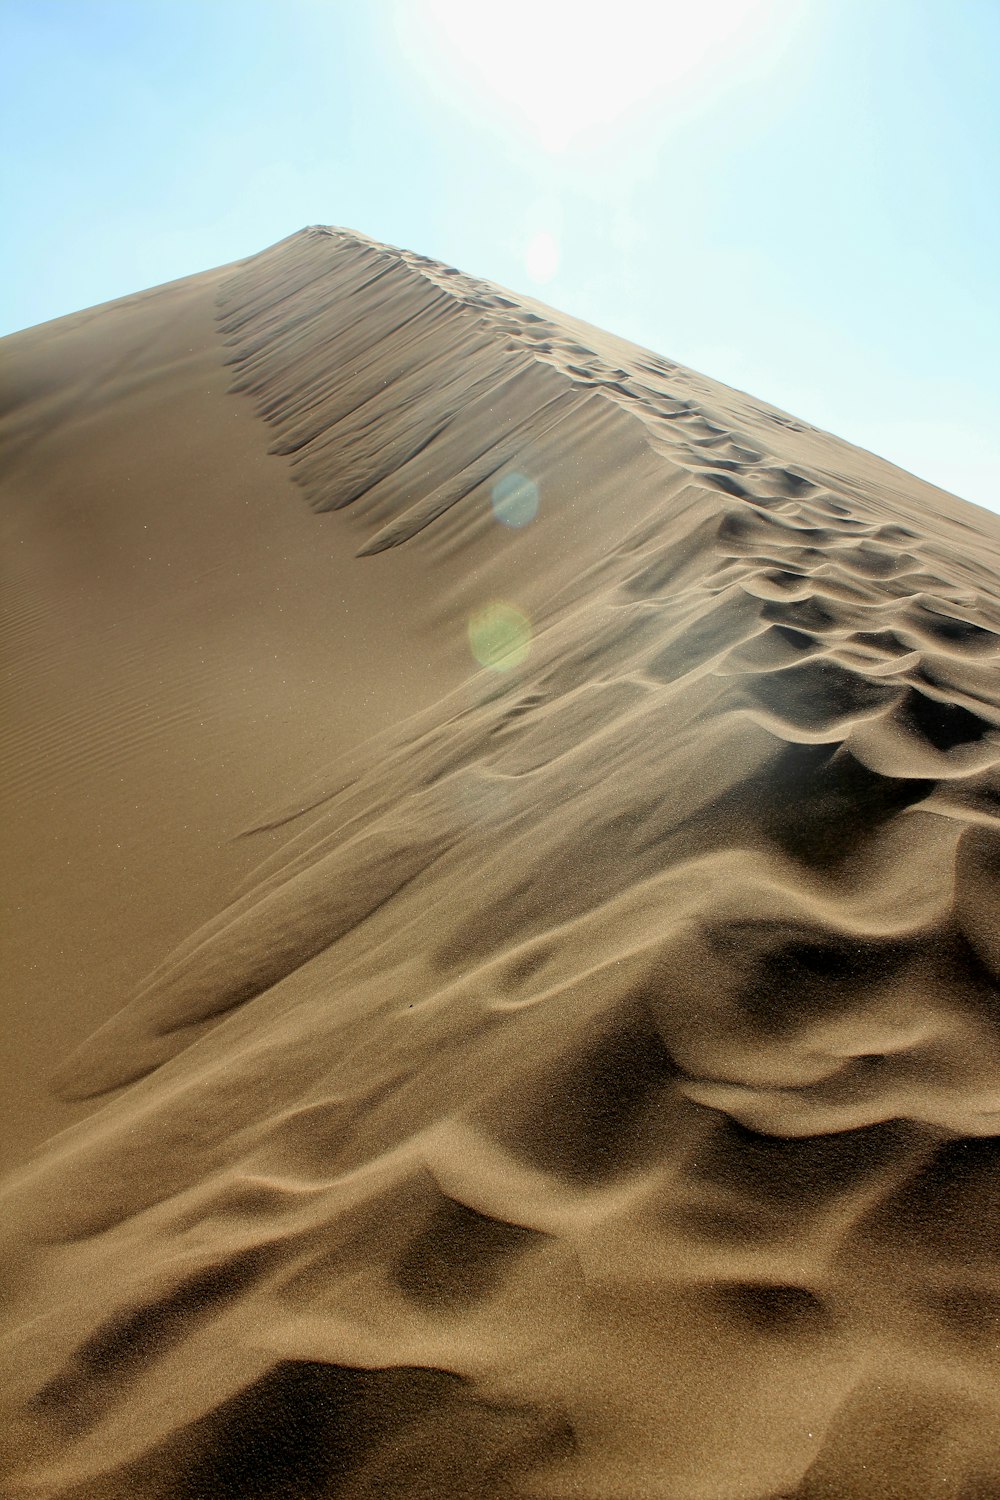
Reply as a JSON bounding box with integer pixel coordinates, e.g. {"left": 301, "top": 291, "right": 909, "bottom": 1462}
{"left": 397, "top": 0, "right": 775, "bottom": 155}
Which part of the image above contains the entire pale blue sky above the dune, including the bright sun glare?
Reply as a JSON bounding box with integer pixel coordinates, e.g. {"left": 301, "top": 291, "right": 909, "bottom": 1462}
{"left": 0, "top": 0, "right": 1000, "bottom": 512}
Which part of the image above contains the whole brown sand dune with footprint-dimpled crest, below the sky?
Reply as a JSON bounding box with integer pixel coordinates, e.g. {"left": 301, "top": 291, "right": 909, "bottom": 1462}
{"left": 1, "top": 230, "right": 1000, "bottom": 1500}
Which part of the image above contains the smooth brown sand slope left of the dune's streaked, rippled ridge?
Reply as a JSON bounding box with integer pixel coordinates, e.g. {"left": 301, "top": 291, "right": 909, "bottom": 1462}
{"left": 0, "top": 246, "right": 468, "bottom": 1160}
